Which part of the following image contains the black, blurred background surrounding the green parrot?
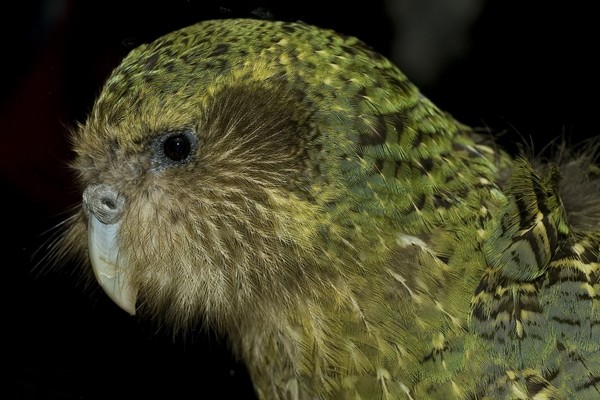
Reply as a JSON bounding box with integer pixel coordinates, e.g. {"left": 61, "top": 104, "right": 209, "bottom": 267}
{"left": 0, "top": 0, "right": 600, "bottom": 399}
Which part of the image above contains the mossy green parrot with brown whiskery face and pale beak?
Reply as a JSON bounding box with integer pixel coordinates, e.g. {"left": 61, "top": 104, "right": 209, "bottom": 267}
{"left": 55, "top": 18, "right": 600, "bottom": 400}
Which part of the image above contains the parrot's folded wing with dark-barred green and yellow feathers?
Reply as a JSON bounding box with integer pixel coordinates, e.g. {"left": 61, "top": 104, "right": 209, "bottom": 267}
{"left": 472, "top": 155, "right": 600, "bottom": 399}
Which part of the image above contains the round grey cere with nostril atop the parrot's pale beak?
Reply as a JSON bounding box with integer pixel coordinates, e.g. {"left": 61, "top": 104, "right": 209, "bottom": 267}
{"left": 83, "top": 184, "right": 125, "bottom": 225}
